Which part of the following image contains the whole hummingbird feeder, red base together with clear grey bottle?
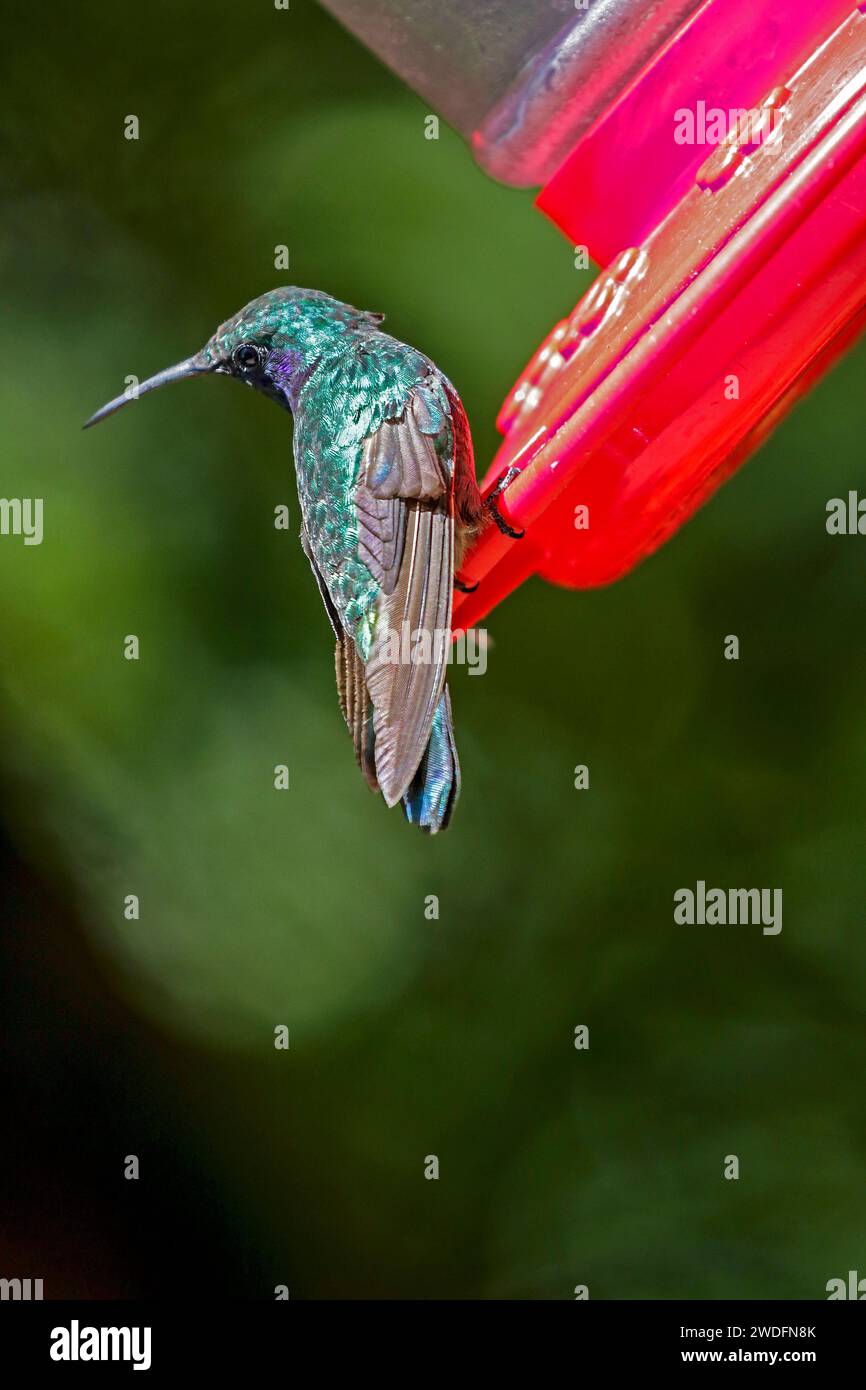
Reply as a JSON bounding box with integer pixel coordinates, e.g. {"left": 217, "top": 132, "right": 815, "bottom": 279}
{"left": 325, "top": 0, "right": 866, "bottom": 628}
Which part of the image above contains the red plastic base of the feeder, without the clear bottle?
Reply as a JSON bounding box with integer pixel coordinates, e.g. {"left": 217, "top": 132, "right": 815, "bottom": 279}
{"left": 455, "top": 0, "right": 866, "bottom": 627}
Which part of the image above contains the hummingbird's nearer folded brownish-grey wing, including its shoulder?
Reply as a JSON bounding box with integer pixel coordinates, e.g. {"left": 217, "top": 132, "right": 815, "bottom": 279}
{"left": 354, "top": 386, "right": 455, "bottom": 806}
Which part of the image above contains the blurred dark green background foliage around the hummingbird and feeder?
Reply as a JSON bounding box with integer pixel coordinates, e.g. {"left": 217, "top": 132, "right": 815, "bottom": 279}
{"left": 0, "top": 0, "right": 866, "bottom": 1298}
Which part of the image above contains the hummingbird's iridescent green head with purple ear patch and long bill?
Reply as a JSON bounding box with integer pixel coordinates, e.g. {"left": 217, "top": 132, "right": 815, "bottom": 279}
{"left": 85, "top": 285, "right": 382, "bottom": 430}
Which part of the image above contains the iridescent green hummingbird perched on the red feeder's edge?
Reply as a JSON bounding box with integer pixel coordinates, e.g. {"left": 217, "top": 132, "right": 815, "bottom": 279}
{"left": 85, "top": 286, "right": 523, "bottom": 834}
